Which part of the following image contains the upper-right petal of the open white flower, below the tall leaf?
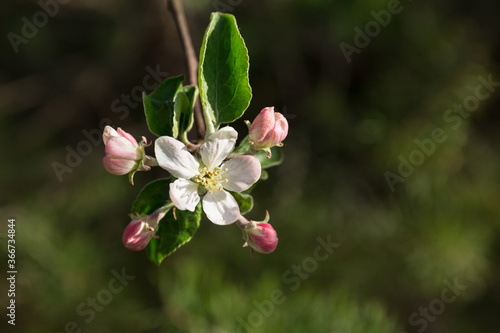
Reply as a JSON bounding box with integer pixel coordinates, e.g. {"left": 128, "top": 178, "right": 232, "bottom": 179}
{"left": 200, "top": 126, "right": 238, "bottom": 170}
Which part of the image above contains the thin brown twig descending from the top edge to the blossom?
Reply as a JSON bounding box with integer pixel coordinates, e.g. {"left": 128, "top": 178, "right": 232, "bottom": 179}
{"left": 167, "top": 0, "right": 205, "bottom": 139}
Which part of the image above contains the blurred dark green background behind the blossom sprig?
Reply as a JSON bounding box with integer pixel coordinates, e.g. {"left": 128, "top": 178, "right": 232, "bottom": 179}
{"left": 0, "top": 0, "right": 500, "bottom": 333}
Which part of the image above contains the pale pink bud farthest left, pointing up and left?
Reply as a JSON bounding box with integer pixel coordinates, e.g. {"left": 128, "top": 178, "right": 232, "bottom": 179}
{"left": 102, "top": 126, "right": 143, "bottom": 175}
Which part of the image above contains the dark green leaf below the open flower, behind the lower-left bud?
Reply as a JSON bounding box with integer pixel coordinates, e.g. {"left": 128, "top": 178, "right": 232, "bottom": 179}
{"left": 132, "top": 178, "right": 201, "bottom": 265}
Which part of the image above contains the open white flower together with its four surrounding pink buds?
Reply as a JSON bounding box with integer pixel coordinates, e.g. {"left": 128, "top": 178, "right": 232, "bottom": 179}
{"left": 103, "top": 107, "right": 288, "bottom": 256}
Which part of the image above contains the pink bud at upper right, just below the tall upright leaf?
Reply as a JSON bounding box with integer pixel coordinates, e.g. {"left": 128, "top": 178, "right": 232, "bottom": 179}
{"left": 249, "top": 107, "right": 288, "bottom": 148}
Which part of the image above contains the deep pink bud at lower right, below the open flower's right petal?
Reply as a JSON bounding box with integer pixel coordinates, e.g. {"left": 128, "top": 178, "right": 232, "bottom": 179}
{"left": 243, "top": 221, "right": 278, "bottom": 253}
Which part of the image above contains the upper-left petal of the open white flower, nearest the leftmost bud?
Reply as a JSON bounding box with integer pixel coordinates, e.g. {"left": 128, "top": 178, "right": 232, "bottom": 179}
{"left": 155, "top": 136, "right": 200, "bottom": 179}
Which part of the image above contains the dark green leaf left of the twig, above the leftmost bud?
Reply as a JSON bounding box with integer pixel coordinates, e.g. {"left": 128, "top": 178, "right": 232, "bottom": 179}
{"left": 142, "top": 75, "right": 184, "bottom": 137}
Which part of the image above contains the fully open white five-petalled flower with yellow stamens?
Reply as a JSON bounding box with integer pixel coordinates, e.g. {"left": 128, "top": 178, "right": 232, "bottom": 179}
{"left": 155, "top": 126, "right": 261, "bottom": 225}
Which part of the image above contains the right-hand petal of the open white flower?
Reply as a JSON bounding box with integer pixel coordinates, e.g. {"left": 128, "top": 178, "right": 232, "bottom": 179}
{"left": 221, "top": 155, "right": 261, "bottom": 192}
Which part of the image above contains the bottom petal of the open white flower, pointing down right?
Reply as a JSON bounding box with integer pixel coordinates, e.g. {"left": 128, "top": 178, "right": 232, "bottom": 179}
{"left": 203, "top": 191, "right": 240, "bottom": 225}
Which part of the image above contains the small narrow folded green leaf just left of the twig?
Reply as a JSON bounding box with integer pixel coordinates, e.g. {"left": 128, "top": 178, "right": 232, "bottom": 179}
{"left": 174, "top": 86, "right": 198, "bottom": 143}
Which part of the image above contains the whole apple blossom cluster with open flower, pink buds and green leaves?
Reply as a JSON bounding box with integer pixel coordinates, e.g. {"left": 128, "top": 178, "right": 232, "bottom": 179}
{"left": 99, "top": 13, "right": 288, "bottom": 264}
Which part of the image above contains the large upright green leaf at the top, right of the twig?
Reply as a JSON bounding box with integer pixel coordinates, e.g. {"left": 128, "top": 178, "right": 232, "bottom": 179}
{"left": 199, "top": 13, "right": 252, "bottom": 132}
